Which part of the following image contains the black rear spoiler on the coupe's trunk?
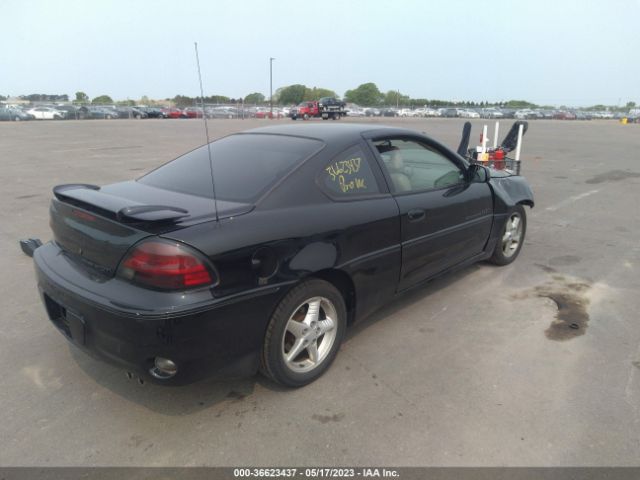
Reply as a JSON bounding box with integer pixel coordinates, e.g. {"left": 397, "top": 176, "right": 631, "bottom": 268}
{"left": 53, "top": 183, "right": 189, "bottom": 223}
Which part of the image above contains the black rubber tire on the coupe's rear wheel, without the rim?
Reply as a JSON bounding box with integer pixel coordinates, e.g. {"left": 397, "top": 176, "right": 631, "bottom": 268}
{"left": 260, "top": 279, "right": 347, "bottom": 387}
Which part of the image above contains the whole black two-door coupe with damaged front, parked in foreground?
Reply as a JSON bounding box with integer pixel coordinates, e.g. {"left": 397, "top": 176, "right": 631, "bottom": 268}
{"left": 34, "top": 124, "right": 533, "bottom": 386}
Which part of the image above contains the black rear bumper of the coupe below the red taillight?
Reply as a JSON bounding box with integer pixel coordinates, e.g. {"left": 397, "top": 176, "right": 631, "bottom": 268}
{"left": 34, "top": 242, "right": 284, "bottom": 385}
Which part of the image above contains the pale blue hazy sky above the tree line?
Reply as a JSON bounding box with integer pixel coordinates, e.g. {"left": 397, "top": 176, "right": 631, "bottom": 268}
{"left": 5, "top": 0, "right": 640, "bottom": 105}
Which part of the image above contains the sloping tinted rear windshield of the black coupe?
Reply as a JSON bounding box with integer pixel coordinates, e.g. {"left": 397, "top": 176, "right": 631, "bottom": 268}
{"left": 138, "top": 134, "right": 323, "bottom": 203}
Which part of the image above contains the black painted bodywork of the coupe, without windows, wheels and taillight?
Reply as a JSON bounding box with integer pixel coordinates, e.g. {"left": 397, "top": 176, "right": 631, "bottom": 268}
{"left": 34, "top": 124, "right": 533, "bottom": 384}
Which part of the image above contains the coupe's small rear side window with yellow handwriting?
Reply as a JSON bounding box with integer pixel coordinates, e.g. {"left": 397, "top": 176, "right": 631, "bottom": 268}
{"left": 318, "top": 146, "right": 380, "bottom": 198}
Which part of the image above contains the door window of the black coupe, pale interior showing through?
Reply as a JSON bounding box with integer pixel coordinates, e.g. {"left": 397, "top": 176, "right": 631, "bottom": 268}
{"left": 374, "top": 138, "right": 464, "bottom": 193}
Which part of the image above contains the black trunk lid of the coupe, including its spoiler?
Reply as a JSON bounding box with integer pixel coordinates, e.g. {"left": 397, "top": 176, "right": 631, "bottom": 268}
{"left": 50, "top": 181, "right": 253, "bottom": 276}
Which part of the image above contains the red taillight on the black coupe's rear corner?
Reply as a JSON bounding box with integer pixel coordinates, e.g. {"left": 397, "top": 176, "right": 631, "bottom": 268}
{"left": 118, "top": 240, "right": 218, "bottom": 290}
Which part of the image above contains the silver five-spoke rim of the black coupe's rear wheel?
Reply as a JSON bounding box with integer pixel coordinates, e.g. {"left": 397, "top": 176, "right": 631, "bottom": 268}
{"left": 281, "top": 297, "right": 338, "bottom": 373}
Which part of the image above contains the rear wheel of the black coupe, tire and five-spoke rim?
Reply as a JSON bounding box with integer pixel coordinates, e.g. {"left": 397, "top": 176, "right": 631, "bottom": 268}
{"left": 261, "top": 279, "right": 347, "bottom": 387}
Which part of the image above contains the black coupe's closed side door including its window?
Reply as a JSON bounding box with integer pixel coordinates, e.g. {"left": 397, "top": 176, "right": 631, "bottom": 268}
{"left": 371, "top": 137, "right": 493, "bottom": 290}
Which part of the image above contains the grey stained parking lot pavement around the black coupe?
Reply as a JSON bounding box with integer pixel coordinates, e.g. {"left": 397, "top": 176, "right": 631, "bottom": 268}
{"left": 0, "top": 119, "right": 640, "bottom": 466}
